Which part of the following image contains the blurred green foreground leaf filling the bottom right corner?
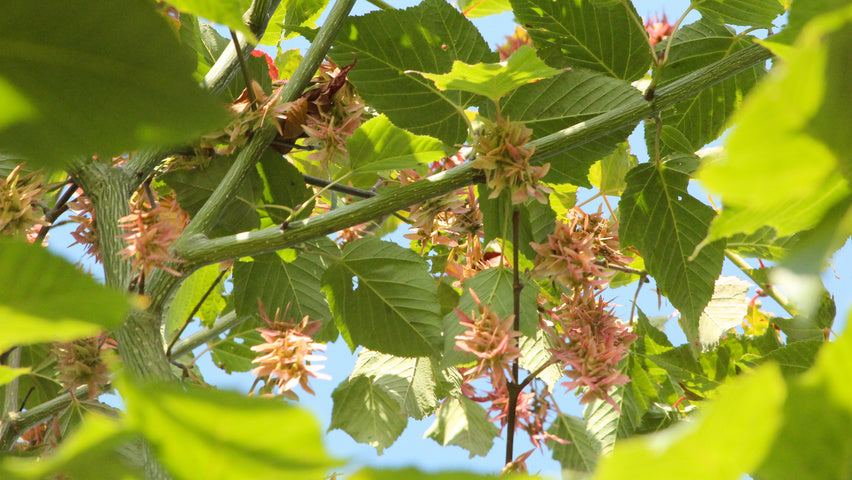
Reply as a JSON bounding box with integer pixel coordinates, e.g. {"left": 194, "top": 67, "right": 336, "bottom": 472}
{"left": 755, "top": 326, "right": 852, "bottom": 480}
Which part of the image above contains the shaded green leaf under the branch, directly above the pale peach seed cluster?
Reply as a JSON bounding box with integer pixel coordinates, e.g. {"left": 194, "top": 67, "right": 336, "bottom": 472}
{"left": 233, "top": 239, "right": 337, "bottom": 341}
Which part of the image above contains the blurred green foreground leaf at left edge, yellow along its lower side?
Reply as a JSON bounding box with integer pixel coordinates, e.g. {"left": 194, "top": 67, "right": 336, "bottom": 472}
{"left": 0, "top": 238, "right": 129, "bottom": 352}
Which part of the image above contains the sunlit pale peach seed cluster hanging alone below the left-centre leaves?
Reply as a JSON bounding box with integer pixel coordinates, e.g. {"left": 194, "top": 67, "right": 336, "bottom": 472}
{"left": 251, "top": 303, "right": 331, "bottom": 400}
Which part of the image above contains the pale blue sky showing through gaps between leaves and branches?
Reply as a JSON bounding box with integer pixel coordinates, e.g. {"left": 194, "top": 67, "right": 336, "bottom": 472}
{"left": 40, "top": 0, "right": 852, "bottom": 478}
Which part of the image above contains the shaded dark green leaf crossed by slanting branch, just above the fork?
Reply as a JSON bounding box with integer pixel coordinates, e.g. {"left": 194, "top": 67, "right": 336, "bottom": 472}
{"left": 161, "top": 157, "right": 263, "bottom": 237}
